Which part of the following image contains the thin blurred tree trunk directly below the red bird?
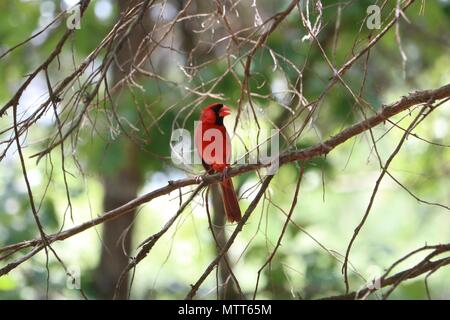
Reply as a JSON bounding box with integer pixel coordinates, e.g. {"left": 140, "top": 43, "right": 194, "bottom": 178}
{"left": 211, "top": 184, "right": 240, "bottom": 300}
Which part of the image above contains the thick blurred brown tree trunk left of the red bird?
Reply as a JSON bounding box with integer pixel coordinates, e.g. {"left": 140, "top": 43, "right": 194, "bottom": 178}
{"left": 95, "top": 0, "right": 145, "bottom": 299}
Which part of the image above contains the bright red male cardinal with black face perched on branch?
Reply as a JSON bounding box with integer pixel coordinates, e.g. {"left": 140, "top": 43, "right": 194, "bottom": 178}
{"left": 195, "top": 103, "right": 242, "bottom": 222}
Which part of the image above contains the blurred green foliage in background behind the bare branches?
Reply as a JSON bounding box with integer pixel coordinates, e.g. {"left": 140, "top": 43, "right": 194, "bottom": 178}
{"left": 0, "top": 0, "right": 450, "bottom": 299}
